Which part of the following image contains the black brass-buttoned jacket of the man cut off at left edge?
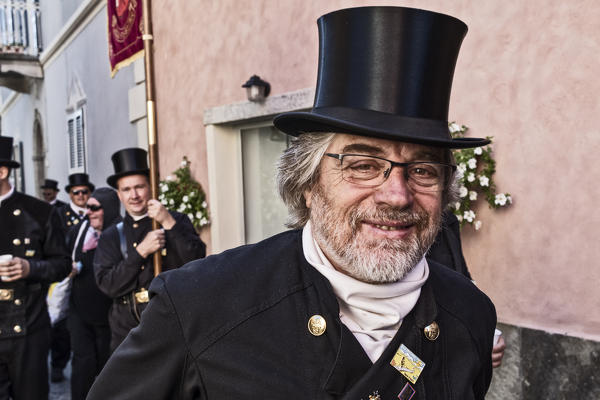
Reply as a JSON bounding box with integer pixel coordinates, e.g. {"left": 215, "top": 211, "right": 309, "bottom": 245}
{"left": 0, "top": 192, "right": 71, "bottom": 339}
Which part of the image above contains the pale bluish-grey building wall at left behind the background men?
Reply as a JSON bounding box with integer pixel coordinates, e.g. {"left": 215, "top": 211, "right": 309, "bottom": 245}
{"left": 2, "top": 0, "right": 143, "bottom": 200}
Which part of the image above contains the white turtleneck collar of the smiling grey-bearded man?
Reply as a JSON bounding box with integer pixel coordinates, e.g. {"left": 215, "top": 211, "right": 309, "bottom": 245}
{"left": 302, "top": 221, "right": 429, "bottom": 362}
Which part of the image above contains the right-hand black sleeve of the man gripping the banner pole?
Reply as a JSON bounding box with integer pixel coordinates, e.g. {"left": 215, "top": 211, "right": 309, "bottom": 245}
{"left": 165, "top": 212, "right": 206, "bottom": 267}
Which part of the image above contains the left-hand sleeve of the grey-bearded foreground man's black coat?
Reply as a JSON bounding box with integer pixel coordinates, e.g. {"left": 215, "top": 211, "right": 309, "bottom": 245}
{"left": 87, "top": 276, "right": 206, "bottom": 400}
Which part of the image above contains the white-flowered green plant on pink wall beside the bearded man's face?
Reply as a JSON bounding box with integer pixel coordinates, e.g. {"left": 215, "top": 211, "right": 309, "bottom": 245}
{"left": 448, "top": 122, "right": 512, "bottom": 230}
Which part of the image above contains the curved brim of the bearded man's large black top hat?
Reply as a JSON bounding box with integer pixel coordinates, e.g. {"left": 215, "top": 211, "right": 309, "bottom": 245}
{"left": 273, "top": 107, "right": 490, "bottom": 149}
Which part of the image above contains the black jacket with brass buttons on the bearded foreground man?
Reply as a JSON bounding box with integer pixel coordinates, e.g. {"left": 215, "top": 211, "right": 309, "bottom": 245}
{"left": 88, "top": 231, "right": 496, "bottom": 400}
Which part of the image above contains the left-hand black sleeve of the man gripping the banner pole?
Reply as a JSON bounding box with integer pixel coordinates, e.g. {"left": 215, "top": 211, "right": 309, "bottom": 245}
{"left": 94, "top": 225, "right": 145, "bottom": 299}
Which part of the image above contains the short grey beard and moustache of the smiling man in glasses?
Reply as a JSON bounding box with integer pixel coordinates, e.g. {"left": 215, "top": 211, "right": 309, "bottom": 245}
{"left": 310, "top": 185, "right": 441, "bottom": 283}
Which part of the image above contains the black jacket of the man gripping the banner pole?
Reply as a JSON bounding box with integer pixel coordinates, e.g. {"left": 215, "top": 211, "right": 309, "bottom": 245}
{"left": 94, "top": 211, "right": 206, "bottom": 341}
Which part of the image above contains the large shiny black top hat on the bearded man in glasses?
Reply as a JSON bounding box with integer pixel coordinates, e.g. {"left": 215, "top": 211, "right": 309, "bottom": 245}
{"left": 274, "top": 7, "right": 489, "bottom": 148}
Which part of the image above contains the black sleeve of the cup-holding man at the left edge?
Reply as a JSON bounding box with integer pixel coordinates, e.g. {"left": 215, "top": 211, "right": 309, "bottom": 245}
{"left": 27, "top": 209, "right": 71, "bottom": 283}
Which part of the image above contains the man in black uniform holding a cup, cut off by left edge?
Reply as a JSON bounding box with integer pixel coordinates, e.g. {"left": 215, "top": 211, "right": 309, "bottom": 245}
{"left": 0, "top": 136, "right": 71, "bottom": 400}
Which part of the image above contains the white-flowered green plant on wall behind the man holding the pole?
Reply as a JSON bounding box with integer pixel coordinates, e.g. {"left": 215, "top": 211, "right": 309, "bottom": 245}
{"left": 158, "top": 156, "right": 210, "bottom": 230}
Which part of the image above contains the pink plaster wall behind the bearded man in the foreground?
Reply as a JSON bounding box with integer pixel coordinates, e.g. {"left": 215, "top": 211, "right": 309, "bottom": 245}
{"left": 153, "top": 0, "right": 600, "bottom": 340}
